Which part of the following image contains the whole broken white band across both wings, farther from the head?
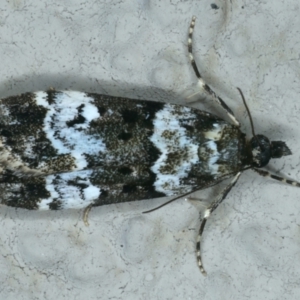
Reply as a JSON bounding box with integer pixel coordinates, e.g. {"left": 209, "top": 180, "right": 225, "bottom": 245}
{"left": 34, "top": 91, "right": 106, "bottom": 209}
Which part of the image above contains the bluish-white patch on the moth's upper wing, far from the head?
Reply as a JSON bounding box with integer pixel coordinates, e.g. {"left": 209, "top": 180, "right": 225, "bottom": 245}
{"left": 36, "top": 91, "right": 105, "bottom": 170}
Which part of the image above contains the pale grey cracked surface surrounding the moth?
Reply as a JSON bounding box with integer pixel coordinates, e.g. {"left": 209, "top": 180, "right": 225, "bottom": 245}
{"left": 0, "top": 0, "right": 300, "bottom": 300}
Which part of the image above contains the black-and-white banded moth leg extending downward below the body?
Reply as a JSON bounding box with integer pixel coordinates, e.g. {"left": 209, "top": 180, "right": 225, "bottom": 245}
{"left": 196, "top": 172, "right": 241, "bottom": 275}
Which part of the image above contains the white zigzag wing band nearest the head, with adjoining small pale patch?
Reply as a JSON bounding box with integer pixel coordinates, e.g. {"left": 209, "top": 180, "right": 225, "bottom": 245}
{"left": 150, "top": 109, "right": 223, "bottom": 196}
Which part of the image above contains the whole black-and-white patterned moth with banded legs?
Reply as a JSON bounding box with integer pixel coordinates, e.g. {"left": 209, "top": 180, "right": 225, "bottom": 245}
{"left": 0, "top": 17, "right": 300, "bottom": 274}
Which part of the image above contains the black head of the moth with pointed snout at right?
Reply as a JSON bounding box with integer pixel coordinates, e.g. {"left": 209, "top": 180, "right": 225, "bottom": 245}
{"left": 250, "top": 134, "right": 292, "bottom": 168}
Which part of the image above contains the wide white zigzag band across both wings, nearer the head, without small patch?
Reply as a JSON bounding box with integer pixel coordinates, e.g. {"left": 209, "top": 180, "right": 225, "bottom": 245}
{"left": 150, "top": 104, "right": 199, "bottom": 196}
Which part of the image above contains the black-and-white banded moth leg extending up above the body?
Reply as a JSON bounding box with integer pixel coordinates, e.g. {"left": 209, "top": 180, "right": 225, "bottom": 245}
{"left": 188, "top": 16, "right": 240, "bottom": 127}
